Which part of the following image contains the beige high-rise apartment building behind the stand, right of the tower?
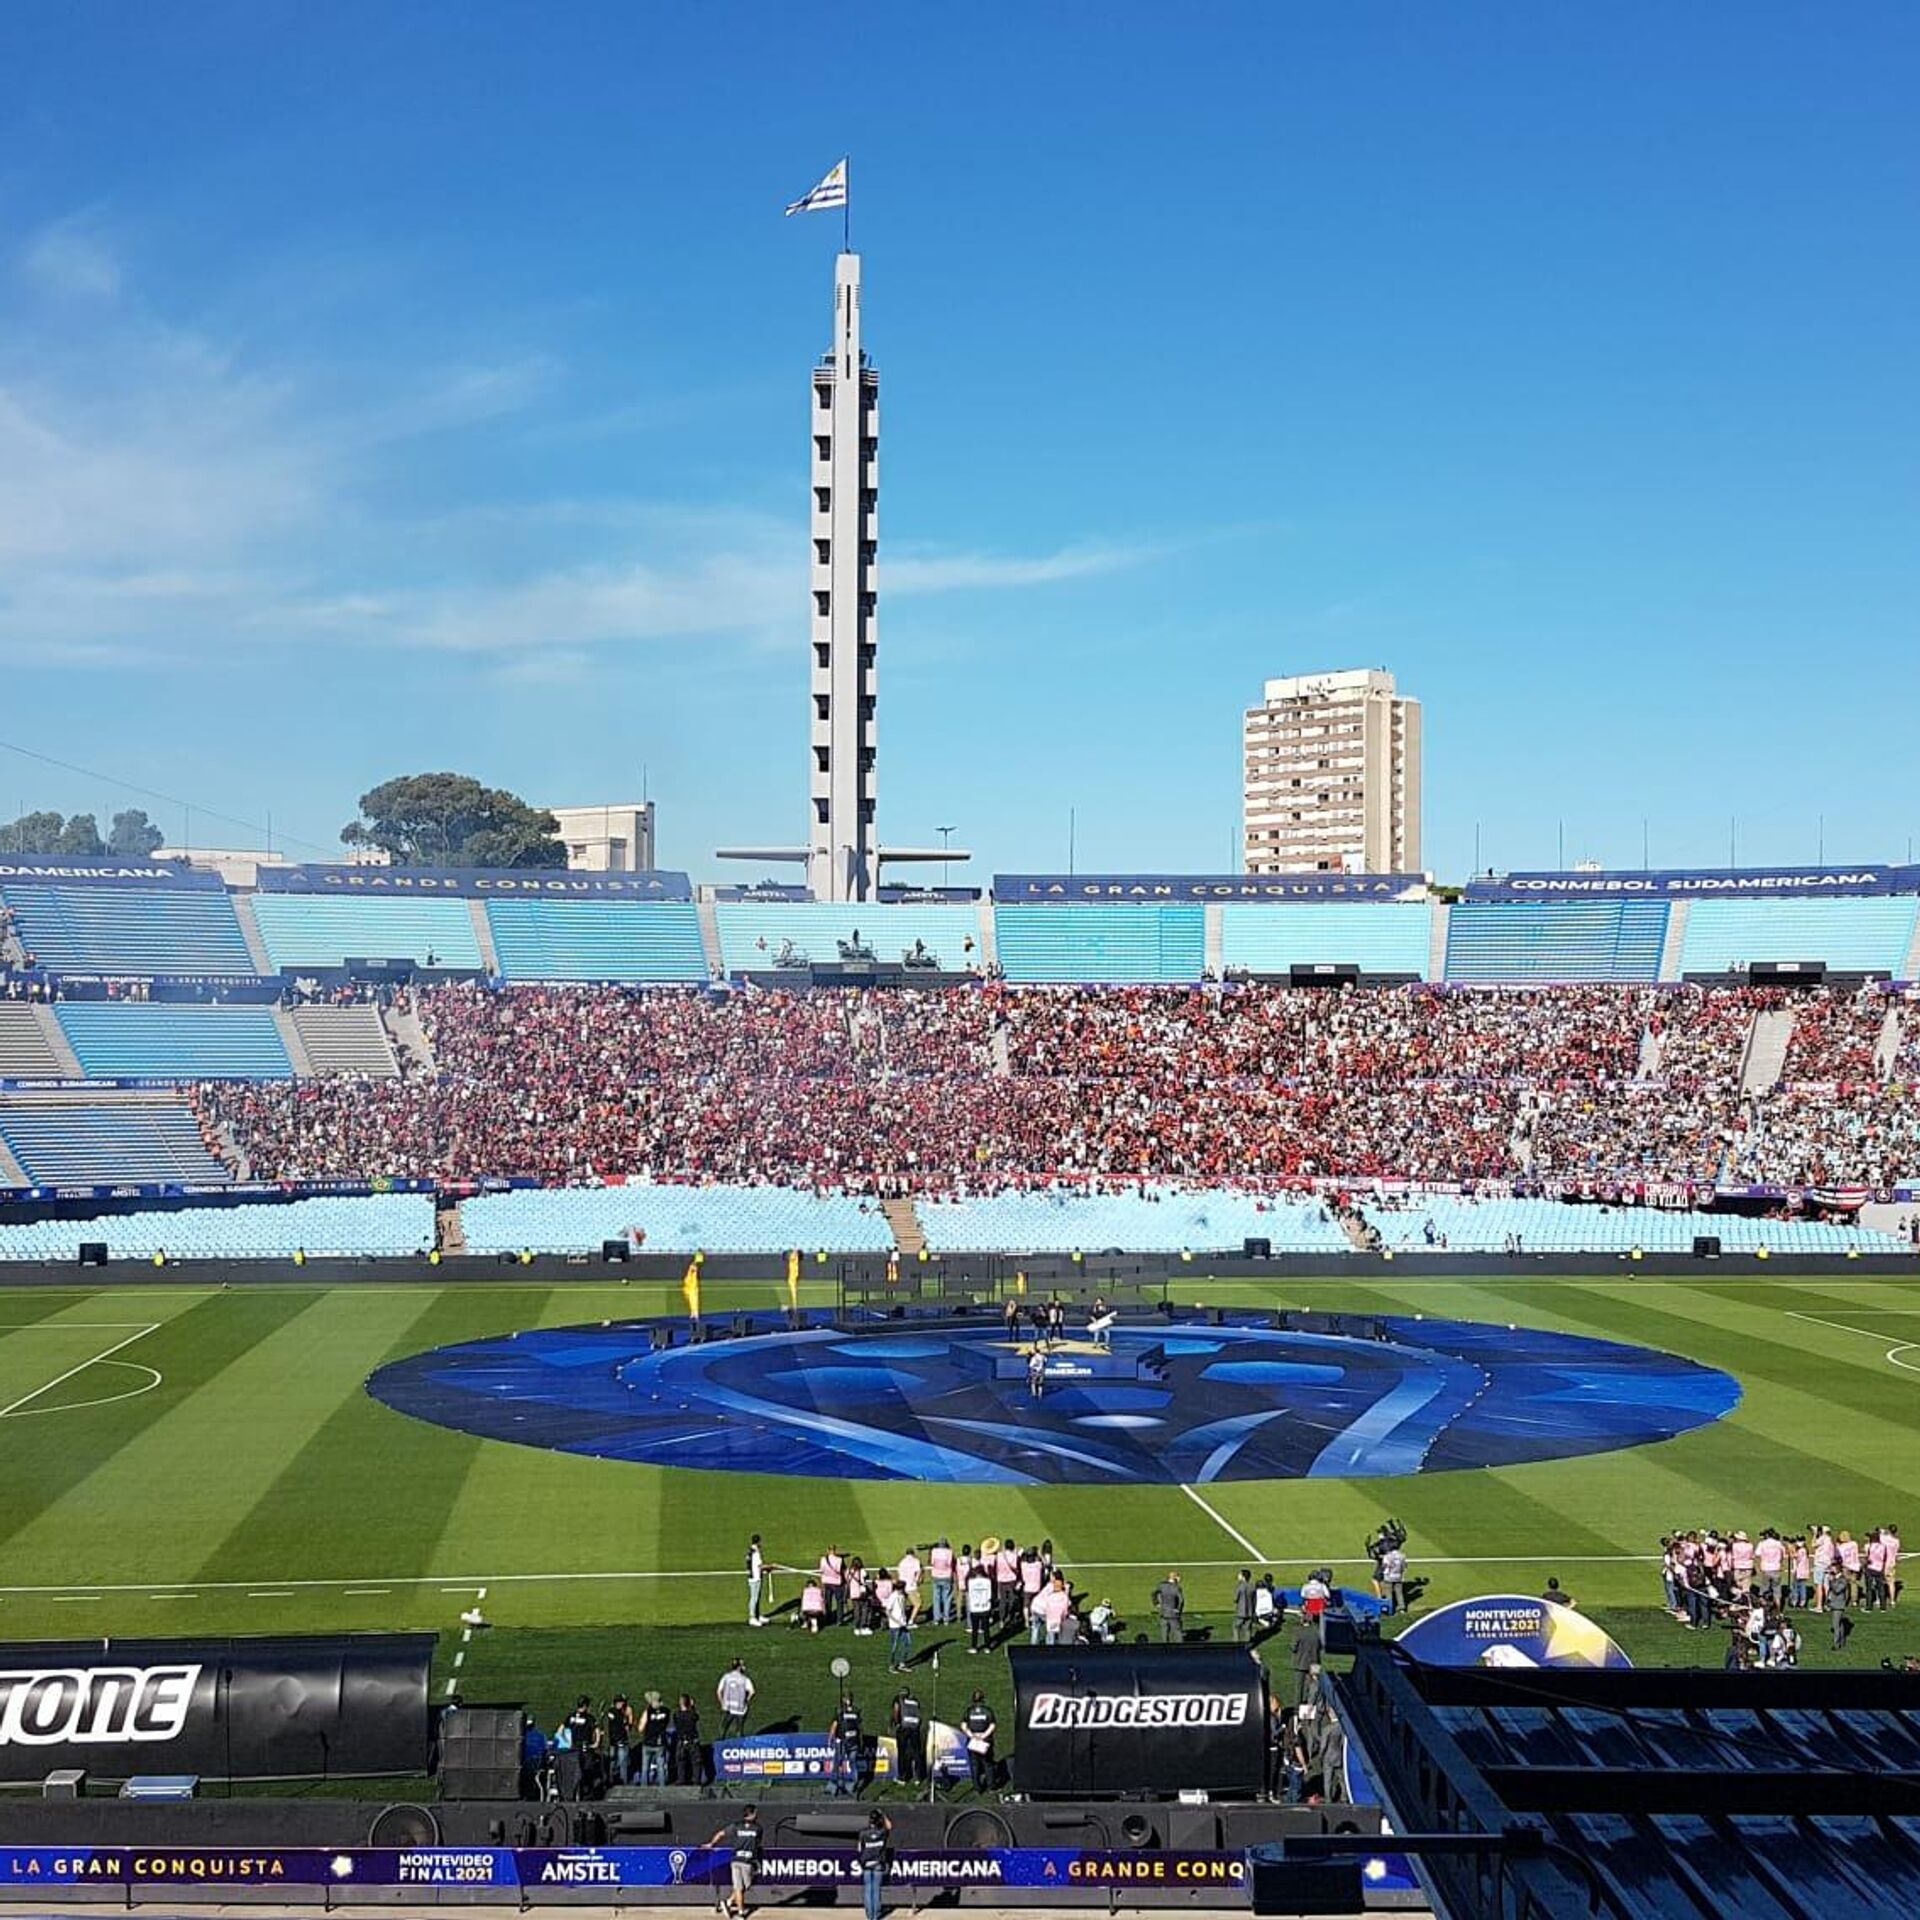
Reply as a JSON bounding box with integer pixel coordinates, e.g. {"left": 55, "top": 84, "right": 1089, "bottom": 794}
{"left": 1240, "top": 668, "right": 1421, "bottom": 874}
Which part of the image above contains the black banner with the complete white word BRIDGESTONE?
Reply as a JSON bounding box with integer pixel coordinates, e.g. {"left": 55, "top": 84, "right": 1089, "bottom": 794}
{"left": 1008, "top": 1647, "right": 1267, "bottom": 1799}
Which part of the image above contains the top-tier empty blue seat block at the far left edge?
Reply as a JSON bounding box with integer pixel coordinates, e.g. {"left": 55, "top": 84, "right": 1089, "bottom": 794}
{"left": 0, "top": 879, "right": 259, "bottom": 979}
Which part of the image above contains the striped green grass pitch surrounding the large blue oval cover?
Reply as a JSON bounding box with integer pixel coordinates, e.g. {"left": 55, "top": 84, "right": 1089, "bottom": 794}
{"left": 0, "top": 1269, "right": 1920, "bottom": 1743}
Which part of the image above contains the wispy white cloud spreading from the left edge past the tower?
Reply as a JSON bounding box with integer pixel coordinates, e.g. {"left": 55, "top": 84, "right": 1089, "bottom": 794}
{"left": 0, "top": 215, "right": 1158, "bottom": 684}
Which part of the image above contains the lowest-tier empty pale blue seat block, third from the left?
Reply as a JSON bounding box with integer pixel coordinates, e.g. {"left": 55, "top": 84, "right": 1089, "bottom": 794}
{"left": 916, "top": 1187, "right": 1352, "bottom": 1254}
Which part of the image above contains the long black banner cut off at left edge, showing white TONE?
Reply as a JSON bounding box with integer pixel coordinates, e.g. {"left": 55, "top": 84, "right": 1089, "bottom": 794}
{"left": 0, "top": 1634, "right": 434, "bottom": 1784}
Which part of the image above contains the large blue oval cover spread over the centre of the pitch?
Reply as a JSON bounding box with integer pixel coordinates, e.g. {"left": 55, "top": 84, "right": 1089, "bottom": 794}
{"left": 367, "top": 1311, "right": 1740, "bottom": 1486}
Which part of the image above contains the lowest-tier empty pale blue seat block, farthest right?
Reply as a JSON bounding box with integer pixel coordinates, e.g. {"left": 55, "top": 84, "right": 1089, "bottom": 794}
{"left": 1359, "top": 1194, "right": 1885, "bottom": 1254}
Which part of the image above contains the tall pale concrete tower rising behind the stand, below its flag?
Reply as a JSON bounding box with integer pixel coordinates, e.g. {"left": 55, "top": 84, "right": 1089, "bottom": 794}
{"left": 806, "top": 253, "right": 879, "bottom": 900}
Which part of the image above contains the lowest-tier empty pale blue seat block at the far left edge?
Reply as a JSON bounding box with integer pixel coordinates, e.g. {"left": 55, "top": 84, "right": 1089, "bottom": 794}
{"left": 0, "top": 1194, "right": 434, "bottom": 1260}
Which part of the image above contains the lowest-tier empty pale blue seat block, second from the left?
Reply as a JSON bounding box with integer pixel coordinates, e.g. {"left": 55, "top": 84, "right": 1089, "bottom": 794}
{"left": 461, "top": 1183, "right": 893, "bottom": 1254}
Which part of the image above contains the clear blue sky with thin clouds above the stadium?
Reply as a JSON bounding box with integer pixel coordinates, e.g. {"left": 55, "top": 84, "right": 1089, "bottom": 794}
{"left": 0, "top": 0, "right": 1920, "bottom": 877}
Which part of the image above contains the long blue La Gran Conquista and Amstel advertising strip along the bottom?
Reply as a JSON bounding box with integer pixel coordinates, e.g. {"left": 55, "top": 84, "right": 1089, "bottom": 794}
{"left": 0, "top": 1847, "right": 1246, "bottom": 1905}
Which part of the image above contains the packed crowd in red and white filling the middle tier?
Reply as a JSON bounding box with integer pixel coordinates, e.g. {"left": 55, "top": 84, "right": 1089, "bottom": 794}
{"left": 196, "top": 983, "right": 1920, "bottom": 1194}
